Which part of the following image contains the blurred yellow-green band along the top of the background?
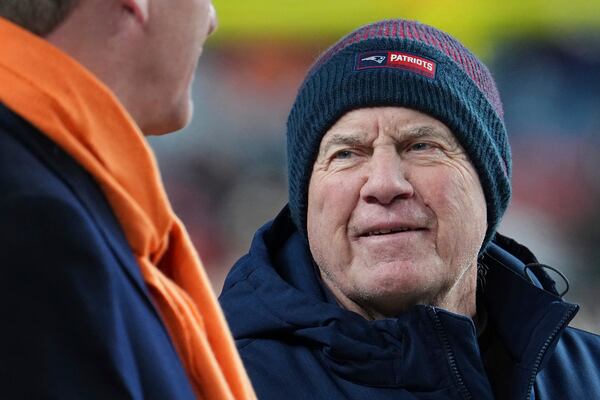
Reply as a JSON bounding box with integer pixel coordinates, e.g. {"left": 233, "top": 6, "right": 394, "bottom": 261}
{"left": 212, "top": 0, "right": 600, "bottom": 57}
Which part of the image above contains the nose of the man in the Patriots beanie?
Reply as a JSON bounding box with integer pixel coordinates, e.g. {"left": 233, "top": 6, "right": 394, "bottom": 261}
{"left": 360, "top": 151, "right": 414, "bottom": 205}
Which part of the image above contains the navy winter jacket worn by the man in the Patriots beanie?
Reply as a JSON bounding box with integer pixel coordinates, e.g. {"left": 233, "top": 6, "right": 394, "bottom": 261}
{"left": 220, "top": 208, "right": 600, "bottom": 400}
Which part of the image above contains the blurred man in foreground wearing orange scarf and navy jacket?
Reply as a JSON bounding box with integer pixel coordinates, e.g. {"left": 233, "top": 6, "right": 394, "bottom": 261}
{"left": 0, "top": 0, "right": 254, "bottom": 399}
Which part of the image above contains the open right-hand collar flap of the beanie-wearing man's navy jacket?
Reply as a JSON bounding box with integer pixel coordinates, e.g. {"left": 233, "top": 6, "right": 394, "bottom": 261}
{"left": 481, "top": 235, "right": 579, "bottom": 398}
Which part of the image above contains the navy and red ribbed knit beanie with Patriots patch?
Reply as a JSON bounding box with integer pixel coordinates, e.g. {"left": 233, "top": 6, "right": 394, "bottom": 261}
{"left": 287, "top": 20, "right": 511, "bottom": 251}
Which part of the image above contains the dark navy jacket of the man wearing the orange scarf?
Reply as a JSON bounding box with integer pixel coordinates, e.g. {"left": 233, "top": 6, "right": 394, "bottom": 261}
{"left": 0, "top": 104, "right": 195, "bottom": 400}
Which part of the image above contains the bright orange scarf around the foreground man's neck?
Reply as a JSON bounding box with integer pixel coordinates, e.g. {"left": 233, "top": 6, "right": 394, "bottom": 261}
{"left": 0, "top": 18, "right": 255, "bottom": 400}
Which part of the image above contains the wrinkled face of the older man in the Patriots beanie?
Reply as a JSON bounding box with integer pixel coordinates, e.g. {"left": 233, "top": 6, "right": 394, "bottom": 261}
{"left": 307, "top": 107, "right": 487, "bottom": 317}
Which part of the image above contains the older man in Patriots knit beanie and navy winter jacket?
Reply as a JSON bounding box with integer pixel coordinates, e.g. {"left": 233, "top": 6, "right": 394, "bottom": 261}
{"left": 220, "top": 20, "right": 600, "bottom": 399}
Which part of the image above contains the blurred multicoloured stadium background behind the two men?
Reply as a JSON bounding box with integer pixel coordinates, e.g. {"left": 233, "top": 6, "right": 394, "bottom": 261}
{"left": 150, "top": 0, "right": 600, "bottom": 333}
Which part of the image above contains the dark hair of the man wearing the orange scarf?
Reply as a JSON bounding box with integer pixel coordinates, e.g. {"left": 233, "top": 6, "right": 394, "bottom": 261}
{"left": 0, "top": 0, "right": 80, "bottom": 36}
